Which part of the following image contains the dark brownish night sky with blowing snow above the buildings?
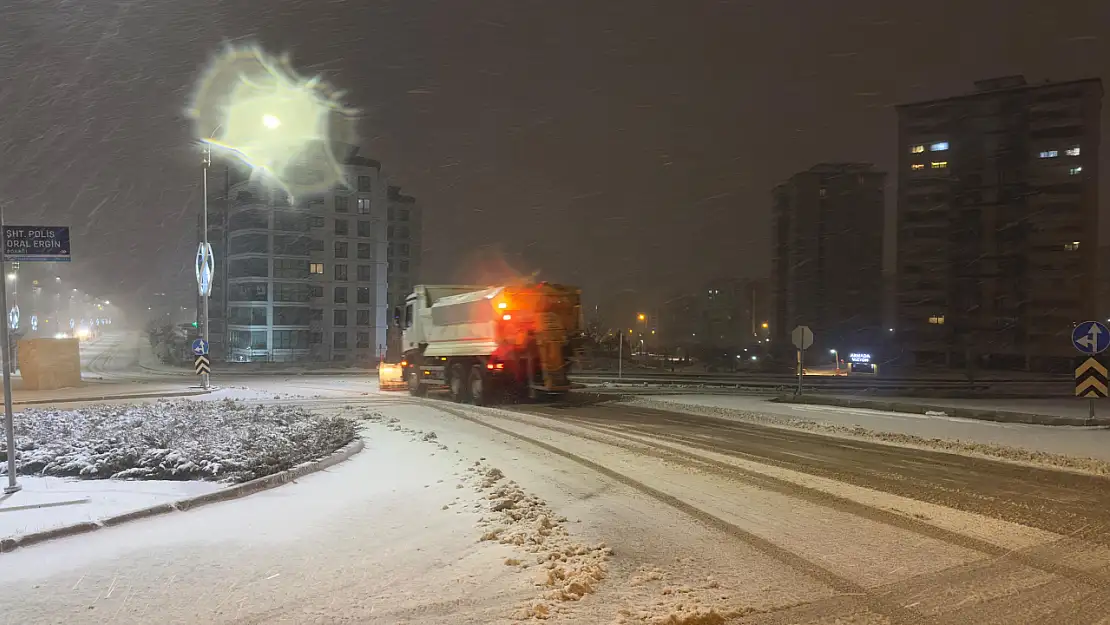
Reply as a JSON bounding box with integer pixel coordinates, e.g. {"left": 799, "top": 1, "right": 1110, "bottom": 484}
{"left": 0, "top": 0, "right": 1110, "bottom": 321}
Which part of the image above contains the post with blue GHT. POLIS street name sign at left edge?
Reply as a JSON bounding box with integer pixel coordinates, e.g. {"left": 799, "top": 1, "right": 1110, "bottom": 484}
{"left": 0, "top": 225, "right": 70, "bottom": 495}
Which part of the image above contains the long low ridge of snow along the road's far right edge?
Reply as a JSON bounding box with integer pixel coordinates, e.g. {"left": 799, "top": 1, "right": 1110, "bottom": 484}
{"left": 622, "top": 397, "right": 1110, "bottom": 475}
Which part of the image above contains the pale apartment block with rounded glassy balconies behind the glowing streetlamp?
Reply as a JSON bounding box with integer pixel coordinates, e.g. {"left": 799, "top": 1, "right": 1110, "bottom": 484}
{"left": 209, "top": 150, "right": 389, "bottom": 363}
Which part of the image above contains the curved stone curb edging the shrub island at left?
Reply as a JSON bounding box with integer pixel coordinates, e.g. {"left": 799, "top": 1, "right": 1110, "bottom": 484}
{"left": 0, "top": 437, "right": 364, "bottom": 553}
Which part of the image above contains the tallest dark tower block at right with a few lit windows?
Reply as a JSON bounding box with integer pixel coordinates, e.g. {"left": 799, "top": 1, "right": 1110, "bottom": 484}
{"left": 895, "top": 77, "right": 1102, "bottom": 371}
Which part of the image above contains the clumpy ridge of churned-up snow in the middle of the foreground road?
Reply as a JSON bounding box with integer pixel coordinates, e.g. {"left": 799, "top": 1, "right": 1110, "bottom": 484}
{"left": 470, "top": 462, "right": 613, "bottom": 619}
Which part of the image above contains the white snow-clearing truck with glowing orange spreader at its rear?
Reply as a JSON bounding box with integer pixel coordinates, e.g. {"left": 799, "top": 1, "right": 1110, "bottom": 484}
{"left": 393, "top": 282, "right": 583, "bottom": 405}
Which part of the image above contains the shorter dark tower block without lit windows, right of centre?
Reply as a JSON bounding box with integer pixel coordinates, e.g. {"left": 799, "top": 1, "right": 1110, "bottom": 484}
{"left": 769, "top": 163, "right": 886, "bottom": 356}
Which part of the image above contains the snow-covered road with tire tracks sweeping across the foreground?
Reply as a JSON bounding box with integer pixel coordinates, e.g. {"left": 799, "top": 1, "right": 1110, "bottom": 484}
{"left": 0, "top": 388, "right": 1110, "bottom": 625}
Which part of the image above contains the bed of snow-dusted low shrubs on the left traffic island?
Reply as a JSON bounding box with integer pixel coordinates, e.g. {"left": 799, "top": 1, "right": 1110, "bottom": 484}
{"left": 0, "top": 400, "right": 355, "bottom": 482}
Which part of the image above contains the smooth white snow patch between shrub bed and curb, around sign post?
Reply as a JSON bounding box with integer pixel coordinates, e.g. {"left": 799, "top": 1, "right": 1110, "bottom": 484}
{"left": 0, "top": 476, "right": 223, "bottom": 540}
